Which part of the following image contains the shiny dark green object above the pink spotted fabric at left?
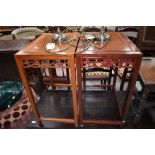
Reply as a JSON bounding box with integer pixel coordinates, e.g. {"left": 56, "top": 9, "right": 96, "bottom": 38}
{"left": 0, "top": 81, "right": 24, "bottom": 111}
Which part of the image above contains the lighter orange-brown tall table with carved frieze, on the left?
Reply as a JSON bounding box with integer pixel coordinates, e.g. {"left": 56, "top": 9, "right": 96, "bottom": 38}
{"left": 15, "top": 33, "right": 78, "bottom": 126}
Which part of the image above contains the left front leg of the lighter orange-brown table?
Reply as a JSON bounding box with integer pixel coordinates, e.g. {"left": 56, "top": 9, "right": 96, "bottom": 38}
{"left": 15, "top": 58, "right": 43, "bottom": 127}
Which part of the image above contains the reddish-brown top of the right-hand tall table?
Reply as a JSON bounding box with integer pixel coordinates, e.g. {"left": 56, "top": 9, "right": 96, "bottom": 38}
{"left": 78, "top": 32, "right": 142, "bottom": 55}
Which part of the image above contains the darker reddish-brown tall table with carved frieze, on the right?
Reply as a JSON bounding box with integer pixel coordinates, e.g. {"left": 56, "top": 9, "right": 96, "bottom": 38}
{"left": 76, "top": 32, "right": 142, "bottom": 125}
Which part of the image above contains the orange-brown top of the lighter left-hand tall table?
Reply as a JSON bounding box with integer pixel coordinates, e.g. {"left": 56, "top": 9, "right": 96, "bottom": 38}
{"left": 15, "top": 33, "right": 78, "bottom": 56}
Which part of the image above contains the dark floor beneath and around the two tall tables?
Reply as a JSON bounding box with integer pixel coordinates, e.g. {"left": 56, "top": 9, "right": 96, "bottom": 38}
{"left": 27, "top": 89, "right": 155, "bottom": 129}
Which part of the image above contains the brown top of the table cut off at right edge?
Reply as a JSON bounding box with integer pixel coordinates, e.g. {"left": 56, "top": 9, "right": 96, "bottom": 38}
{"left": 139, "top": 57, "right": 155, "bottom": 85}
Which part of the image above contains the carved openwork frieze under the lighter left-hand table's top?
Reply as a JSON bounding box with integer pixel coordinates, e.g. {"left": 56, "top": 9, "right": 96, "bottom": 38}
{"left": 23, "top": 60, "right": 69, "bottom": 68}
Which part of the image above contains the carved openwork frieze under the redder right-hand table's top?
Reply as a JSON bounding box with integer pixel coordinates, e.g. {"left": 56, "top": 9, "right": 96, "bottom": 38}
{"left": 81, "top": 58, "right": 135, "bottom": 69}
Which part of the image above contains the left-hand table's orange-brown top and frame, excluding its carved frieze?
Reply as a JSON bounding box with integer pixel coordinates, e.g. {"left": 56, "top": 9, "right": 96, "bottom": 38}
{"left": 15, "top": 33, "right": 78, "bottom": 127}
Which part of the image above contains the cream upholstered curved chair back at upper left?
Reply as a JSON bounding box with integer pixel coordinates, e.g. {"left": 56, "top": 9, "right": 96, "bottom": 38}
{"left": 11, "top": 27, "right": 44, "bottom": 40}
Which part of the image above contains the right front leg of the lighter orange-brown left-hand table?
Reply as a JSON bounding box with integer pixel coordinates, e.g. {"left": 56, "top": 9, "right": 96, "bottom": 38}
{"left": 69, "top": 56, "right": 78, "bottom": 127}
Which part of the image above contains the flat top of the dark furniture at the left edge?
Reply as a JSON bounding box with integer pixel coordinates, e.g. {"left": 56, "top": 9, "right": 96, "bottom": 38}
{"left": 0, "top": 40, "right": 30, "bottom": 52}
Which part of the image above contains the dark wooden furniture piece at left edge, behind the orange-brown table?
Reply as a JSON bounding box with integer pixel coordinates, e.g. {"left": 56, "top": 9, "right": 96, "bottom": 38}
{"left": 0, "top": 40, "right": 30, "bottom": 82}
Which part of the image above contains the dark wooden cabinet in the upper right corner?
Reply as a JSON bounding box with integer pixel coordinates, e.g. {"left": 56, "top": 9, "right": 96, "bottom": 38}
{"left": 137, "top": 26, "right": 155, "bottom": 52}
